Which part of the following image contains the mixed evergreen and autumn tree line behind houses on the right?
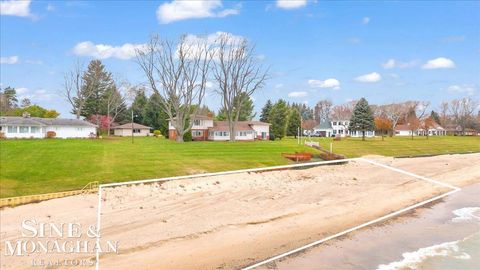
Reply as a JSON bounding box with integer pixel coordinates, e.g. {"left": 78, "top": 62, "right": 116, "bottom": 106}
{"left": 260, "top": 97, "right": 480, "bottom": 139}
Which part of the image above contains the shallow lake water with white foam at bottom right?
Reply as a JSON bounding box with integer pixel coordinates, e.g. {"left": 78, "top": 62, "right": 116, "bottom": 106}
{"left": 270, "top": 184, "right": 480, "bottom": 270}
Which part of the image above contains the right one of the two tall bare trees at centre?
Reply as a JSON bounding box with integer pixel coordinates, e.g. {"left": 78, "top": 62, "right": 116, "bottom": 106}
{"left": 213, "top": 34, "right": 267, "bottom": 142}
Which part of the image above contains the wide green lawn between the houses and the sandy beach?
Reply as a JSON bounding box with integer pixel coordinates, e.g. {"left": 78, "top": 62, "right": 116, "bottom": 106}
{"left": 0, "top": 137, "right": 480, "bottom": 198}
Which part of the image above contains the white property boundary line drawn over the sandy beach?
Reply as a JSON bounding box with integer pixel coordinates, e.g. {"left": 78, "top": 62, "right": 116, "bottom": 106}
{"left": 95, "top": 158, "right": 461, "bottom": 270}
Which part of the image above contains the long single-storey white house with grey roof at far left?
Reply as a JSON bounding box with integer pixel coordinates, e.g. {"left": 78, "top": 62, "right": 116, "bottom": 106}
{"left": 0, "top": 116, "right": 97, "bottom": 138}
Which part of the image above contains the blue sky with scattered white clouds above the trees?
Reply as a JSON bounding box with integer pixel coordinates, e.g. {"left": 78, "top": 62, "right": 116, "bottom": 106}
{"left": 0, "top": 0, "right": 480, "bottom": 118}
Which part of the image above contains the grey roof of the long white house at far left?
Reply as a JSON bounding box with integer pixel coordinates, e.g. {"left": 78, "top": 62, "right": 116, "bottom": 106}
{"left": 0, "top": 116, "right": 96, "bottom": 127}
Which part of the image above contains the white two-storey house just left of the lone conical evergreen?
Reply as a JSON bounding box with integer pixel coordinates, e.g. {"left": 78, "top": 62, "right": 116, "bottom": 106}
{"left": 312, "top": 119, "right": 375, "bottom": 137}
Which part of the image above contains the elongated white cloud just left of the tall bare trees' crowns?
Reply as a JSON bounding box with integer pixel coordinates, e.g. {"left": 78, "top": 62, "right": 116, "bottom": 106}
{"left": 73, "top": 41, "right": 146, "bottom": 60}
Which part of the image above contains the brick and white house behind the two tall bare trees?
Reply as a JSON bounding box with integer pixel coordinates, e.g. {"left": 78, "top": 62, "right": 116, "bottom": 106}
{"left": 168, "top": 115, "right": 270, "bottom": 141}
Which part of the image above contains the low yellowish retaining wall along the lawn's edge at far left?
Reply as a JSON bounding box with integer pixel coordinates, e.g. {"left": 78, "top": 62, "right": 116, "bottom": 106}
{"left": 0, "top": 181, "right": 99, "bottom": 208}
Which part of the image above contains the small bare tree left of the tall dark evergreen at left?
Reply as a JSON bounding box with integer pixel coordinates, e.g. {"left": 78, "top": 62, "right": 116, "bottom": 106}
{"left": 63, "top": 62, "right": 94, "bottom": 119}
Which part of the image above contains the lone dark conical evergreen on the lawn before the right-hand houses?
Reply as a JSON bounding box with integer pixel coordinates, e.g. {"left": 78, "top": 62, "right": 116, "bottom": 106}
{"left": 348, "top": 98, "right": 375, "bottom": 140}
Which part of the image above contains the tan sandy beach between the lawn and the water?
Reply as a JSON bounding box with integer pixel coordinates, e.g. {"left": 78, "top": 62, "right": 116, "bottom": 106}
{"left": 0, "top": 154, "right": 480, "bottom": 269}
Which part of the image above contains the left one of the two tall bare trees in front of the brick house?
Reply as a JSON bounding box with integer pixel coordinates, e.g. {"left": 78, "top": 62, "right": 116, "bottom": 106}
{"left": 137, "top": 36, "right": 212, "bottom": 142}
